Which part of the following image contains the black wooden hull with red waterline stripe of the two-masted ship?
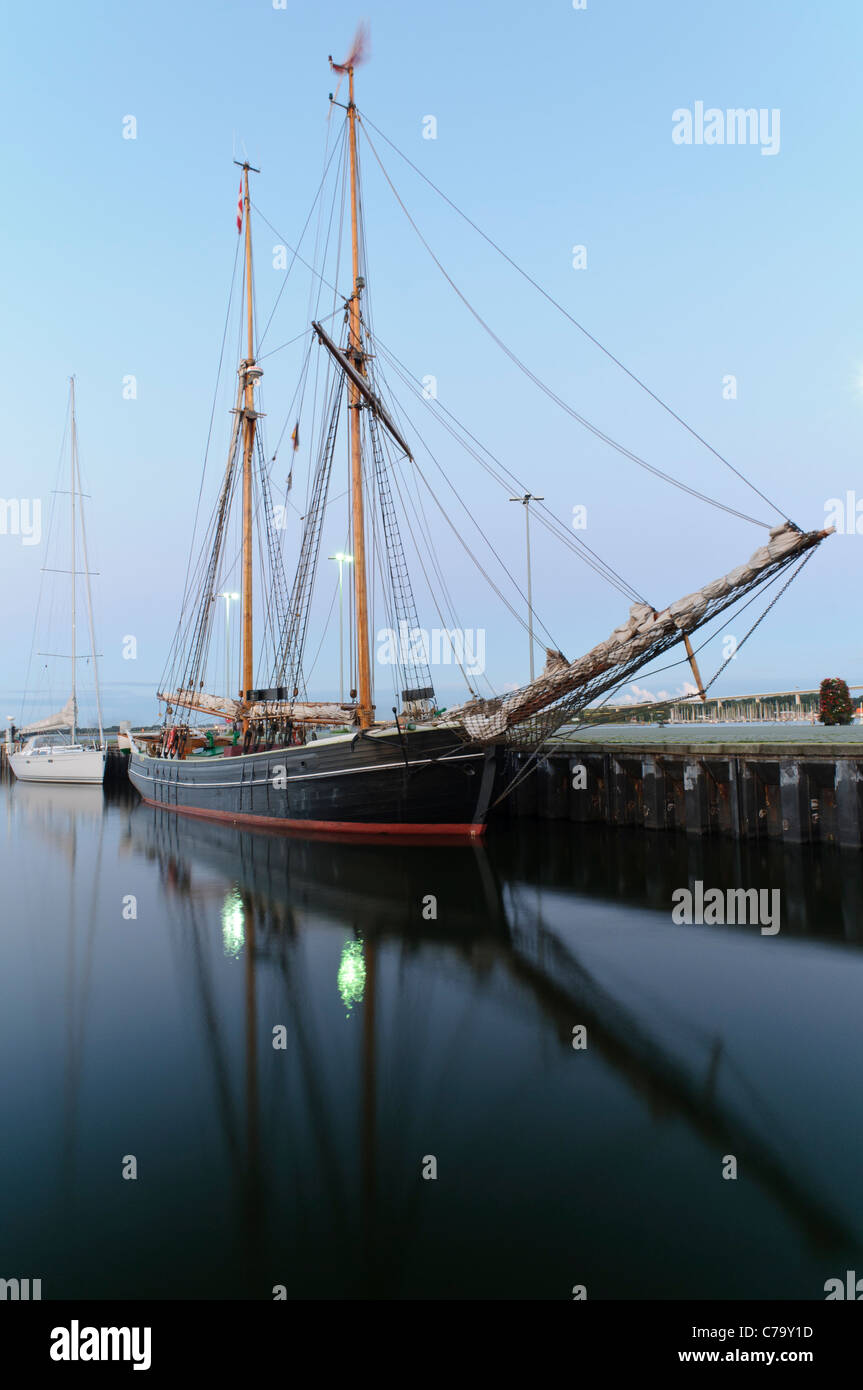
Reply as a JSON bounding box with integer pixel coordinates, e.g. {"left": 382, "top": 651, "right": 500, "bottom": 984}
{"left": 129, "top": 727, "right": 495, "bottom": 838}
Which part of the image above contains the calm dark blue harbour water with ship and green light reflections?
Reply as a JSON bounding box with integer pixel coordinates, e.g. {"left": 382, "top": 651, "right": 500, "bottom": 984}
{"left": 0, "top": 783, "right": 863, "bottom": 1298}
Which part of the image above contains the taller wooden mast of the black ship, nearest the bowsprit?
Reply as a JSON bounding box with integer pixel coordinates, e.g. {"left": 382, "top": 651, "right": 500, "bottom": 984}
{"left": 347, "top": 65, "right": 374, "bottom": 728}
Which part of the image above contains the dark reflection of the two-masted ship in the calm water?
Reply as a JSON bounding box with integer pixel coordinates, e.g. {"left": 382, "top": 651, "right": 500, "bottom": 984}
{"left": 129, "top": 805, "right": 855, "bottom": 1297}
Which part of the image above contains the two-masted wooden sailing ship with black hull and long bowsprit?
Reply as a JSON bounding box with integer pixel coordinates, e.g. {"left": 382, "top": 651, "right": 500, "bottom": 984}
{"left": 129, "top": 35, "right": 828, "bottom": 837}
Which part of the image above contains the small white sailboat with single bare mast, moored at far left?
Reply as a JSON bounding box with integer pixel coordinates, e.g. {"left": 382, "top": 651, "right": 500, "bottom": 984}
{"left": 10, "top": 377, "right": 106, "bottom": 784}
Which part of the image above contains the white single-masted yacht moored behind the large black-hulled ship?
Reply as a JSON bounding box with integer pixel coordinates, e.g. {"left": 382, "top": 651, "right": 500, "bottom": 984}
{"left": 8, "top": 377, "right": 106, "bottom": 784}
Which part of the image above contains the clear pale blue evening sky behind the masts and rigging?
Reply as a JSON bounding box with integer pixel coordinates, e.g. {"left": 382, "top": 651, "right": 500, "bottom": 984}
{"left": 0, "top": 0, "right": 863, "bottom": 720}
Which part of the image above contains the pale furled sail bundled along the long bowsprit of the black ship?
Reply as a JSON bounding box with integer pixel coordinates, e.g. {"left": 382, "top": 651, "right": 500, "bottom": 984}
{"left": 447, "top": 521, "right": 832, "bottom": 744}
